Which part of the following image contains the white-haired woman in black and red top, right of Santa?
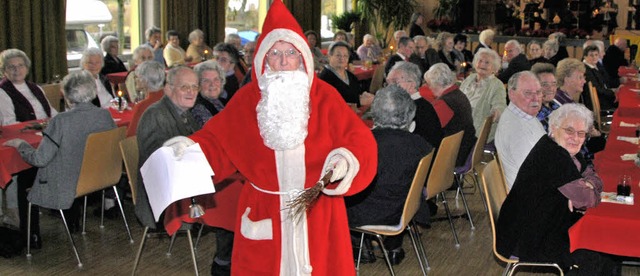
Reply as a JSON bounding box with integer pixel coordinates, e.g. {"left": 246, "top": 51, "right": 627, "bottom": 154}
{"left": 424, "top": 63, "right": 476, "bottom": 166}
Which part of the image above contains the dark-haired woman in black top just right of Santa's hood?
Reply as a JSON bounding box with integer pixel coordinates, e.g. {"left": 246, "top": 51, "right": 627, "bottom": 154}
{"left": 318, "top": 41, "right": 373, "bottom": 106}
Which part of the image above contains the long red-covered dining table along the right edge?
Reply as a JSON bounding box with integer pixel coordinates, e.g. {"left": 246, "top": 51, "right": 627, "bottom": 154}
{"left": 569, "top": 78, "right": 640, "bottom": 257}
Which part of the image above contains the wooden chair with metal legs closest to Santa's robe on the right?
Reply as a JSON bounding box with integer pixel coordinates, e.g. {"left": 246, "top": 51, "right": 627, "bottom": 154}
{"left": 351, "top": 151, "right": 433, "bottom": 275}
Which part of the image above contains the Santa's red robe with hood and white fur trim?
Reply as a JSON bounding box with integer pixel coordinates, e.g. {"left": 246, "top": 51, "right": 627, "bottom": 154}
{"left": 190, "top": 1, "right": 377, "bottom": 275}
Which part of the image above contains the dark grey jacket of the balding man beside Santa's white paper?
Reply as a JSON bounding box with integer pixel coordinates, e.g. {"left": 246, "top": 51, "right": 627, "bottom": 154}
{"left": 135, "top": 96, "right": 200, "bottom": 229}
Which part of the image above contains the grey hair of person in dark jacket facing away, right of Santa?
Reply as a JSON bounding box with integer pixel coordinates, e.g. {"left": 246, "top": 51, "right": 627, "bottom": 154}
{"left": 371, "top": 85, "right": 416, "bottom": 130}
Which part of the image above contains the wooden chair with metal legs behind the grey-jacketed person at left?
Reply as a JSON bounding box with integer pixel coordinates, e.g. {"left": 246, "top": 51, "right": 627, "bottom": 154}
{"left": 27, "top": 127, "right": 133, "bottom": 267}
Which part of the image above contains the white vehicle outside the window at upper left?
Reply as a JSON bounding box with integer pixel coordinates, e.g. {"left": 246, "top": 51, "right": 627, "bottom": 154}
{"left": 65, "top": 0, "right": 113, "bottom": 69}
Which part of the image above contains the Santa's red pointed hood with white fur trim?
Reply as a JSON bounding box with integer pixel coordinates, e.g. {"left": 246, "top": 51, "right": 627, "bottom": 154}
{"left": 253, "top": 0, "right": 314, "bottom": 84}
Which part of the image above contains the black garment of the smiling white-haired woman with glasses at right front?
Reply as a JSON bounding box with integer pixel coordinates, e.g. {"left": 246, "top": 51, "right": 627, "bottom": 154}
{"left": 496, "top": 135, "right": 586, "bottom": 267}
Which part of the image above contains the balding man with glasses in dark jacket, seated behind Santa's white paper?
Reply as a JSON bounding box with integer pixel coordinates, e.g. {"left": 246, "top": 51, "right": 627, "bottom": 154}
{"left": 135, "top": 66, "right": 200, "bottom": 231}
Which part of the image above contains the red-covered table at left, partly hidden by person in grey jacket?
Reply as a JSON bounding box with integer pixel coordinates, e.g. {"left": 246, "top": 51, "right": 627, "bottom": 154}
{"left": 0, "top": 107, "right": 133, "bottom": 189}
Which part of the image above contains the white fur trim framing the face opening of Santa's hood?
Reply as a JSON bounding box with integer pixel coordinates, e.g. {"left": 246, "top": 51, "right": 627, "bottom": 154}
{"left": 253, "top": 29, "right": 315, "bottom": 86}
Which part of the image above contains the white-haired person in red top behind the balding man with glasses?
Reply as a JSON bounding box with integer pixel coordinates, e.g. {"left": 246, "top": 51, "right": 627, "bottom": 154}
{"left": 127, "top": 60, "right": 165, "bottom": 137}
